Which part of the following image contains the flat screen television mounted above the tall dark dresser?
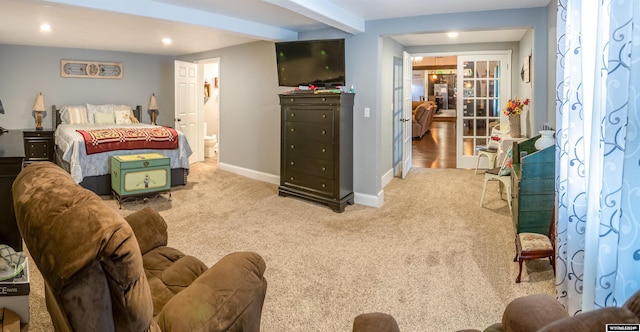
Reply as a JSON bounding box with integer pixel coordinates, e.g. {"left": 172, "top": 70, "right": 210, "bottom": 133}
{"left": 276, "top": 39, "right": 346, "bottom": 88}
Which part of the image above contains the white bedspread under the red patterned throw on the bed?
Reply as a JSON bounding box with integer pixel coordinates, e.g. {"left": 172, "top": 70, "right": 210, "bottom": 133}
{"left": 55, "top": 123, "right": 192, "bottom": 183}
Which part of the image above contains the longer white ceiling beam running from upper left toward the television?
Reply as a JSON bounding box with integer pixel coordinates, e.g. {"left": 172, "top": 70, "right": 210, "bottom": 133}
{"left": 46, "top": 0, "right": 298, "bottom": 40}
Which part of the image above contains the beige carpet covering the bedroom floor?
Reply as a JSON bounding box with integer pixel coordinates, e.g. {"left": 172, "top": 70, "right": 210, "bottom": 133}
{"left": 22, "top": 163, "right": 555, "bottom": 332}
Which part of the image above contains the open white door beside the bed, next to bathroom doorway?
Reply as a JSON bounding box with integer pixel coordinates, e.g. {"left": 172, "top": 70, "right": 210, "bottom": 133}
{"left": 174, "top": 60, "right": 199, "bottom": 163}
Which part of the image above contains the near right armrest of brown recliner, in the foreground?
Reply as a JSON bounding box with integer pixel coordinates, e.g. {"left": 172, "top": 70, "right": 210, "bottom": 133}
{"left": 155, "top": 252, "right": 267, "bottom": 332}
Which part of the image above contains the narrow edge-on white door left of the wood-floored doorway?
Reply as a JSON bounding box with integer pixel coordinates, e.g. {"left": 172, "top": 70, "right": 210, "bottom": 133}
{"left": 400, "top": 52, "right": 413, "bottom": 179}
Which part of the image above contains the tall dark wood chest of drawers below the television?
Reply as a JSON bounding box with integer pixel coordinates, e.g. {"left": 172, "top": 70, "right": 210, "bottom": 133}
{"left": 278, "top": 93, "right": 355, "bottom": 212}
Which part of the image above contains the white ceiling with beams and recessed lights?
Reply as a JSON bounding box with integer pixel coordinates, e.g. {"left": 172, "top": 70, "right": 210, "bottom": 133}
{"left": 0, "top": 0, "right": 550, "bottom": 56}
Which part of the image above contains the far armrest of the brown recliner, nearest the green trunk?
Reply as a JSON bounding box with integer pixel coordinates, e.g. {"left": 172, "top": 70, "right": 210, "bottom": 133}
{"left": 124, "top": 207, "right": 168, "bottom": 255}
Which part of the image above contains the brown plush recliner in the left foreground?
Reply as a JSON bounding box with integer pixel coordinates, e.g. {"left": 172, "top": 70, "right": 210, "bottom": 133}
{"left": 13, "top": 162, "right": 267, "bottom": 331}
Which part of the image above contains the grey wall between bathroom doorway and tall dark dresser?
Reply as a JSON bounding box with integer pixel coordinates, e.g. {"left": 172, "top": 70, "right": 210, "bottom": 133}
{"left": 180, "top": 41, "right": 290, "bottom": 182}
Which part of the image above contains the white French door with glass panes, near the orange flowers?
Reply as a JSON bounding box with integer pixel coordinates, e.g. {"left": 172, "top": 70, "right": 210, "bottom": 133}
{"left": 456, "top": 52, "right": 511, "bottom": 168}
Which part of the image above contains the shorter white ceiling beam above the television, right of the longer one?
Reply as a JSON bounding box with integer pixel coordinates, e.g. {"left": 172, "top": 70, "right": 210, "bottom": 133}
{"left": 262, "top": 0, "right": 364, "bottom": 35}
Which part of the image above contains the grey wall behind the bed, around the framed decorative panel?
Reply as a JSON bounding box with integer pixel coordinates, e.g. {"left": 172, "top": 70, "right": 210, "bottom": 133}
{"left": 0, "top": 45, "right": 174, "bottom": 129}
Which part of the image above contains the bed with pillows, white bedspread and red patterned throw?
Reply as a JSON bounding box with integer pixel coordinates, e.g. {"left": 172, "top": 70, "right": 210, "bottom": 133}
{"left": 52, "top": 104, "right": 192, "bottom": 195}
